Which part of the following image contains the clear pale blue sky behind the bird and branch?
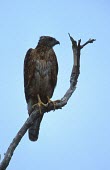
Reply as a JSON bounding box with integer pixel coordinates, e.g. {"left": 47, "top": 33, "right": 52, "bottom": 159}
{"left": 0, "top": 0, "right": 110, "bottom": 170}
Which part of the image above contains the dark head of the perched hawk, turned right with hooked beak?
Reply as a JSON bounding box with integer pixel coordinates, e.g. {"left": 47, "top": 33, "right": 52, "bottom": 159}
{"left": 38, "top": 36, "right": 60, "bottom": 48}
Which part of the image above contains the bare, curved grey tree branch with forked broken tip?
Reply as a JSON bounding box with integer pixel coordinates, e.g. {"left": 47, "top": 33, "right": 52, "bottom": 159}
{"left": 0, "top": 34, "right": 95, "bottom": 170}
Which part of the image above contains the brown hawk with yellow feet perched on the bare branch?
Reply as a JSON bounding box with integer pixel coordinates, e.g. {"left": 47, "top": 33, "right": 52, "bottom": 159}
{"left": 24, "top": 36, "right": 60, "bottom": 141}
